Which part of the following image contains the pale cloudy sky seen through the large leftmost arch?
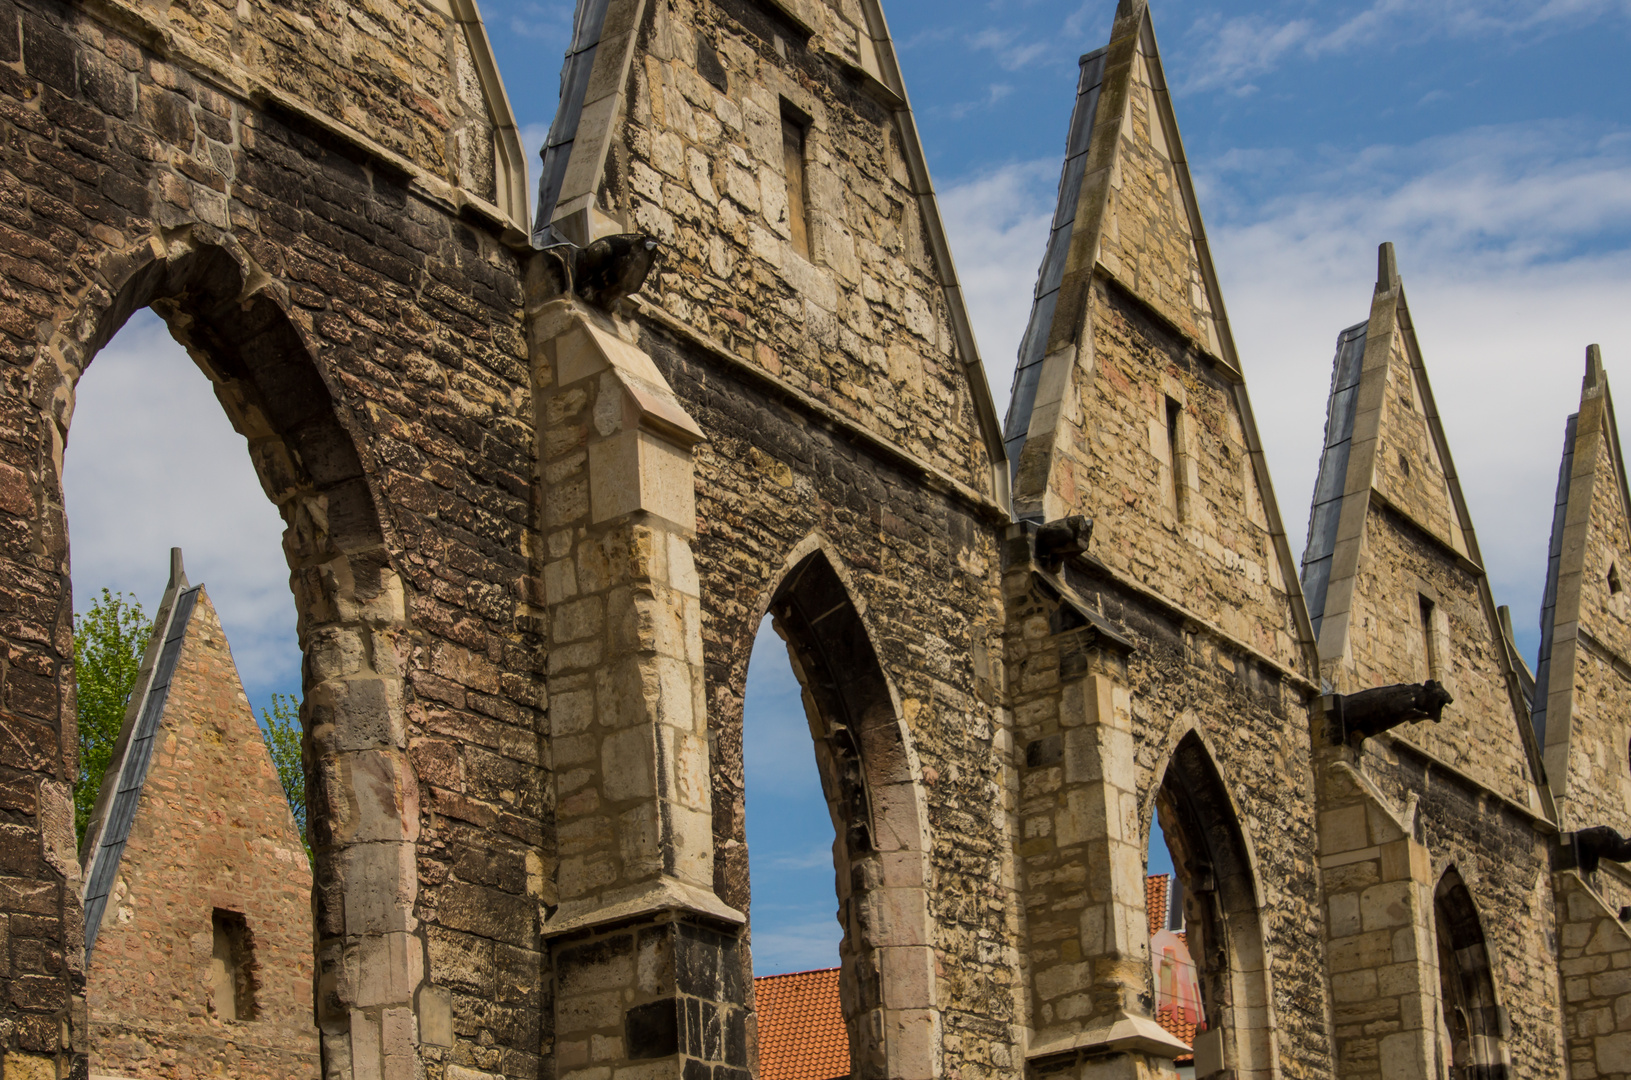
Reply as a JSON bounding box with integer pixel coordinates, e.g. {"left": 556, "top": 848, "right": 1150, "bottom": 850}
{"left": 64, "top": 312, "right": 300, "bottom": 711}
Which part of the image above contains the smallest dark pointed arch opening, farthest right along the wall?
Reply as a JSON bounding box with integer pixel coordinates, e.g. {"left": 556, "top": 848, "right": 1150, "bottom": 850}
{"left": 1434, "top": 868, "right": 1509, "bottom": 1080}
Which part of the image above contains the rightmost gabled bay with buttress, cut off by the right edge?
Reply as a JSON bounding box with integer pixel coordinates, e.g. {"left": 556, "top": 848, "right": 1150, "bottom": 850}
{"left": 1533, "top": 346, "right": 1631, "bottom": 1080}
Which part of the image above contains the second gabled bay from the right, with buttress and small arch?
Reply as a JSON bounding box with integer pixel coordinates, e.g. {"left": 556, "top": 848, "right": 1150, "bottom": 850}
{"left": 1303, "top": 245, "right": 1556, "bottom": 1080}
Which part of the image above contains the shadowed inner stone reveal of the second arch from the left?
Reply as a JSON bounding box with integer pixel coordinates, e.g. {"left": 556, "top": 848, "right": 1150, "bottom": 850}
{"left": 737, "top": 543, "right": 938, "bottom": 1080}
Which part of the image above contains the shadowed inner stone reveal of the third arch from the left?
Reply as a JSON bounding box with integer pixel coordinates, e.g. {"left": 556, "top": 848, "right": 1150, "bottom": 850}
{"left": 1155, "top": 731, "right": 1274, "bottom": 1078}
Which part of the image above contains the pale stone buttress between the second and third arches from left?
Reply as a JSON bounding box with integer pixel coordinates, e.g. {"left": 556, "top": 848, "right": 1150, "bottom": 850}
{"left": 1006, "top": 551, "right": 1189, "bottom": 1077}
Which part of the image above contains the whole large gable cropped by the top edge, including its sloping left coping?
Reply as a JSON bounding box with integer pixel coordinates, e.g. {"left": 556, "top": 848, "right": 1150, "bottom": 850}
{"left": 533, "top": 0, "right": 1008, "bottom": 502}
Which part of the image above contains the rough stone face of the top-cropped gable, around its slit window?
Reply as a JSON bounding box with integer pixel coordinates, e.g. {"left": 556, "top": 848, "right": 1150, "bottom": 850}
{"left": 600, "top": 0, "right": 990, "bottom": 489}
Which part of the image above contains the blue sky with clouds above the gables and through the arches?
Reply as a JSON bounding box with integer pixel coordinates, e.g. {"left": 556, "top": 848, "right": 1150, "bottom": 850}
{"left": 67, "top": 0, "right": 1631, "bottom": 972}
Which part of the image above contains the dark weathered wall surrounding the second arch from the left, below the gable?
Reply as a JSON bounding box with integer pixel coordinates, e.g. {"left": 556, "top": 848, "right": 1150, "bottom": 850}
{"left": 643, "top": 318, "right": 1023, "bottom": 1077}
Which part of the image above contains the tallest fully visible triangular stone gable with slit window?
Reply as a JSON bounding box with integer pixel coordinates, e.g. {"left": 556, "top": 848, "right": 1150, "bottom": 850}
{"left": 1005, "top": 0, "right": 1315, "bottom": 674}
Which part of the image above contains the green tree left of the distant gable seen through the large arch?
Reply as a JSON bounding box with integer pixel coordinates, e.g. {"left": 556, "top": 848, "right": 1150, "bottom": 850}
{"left": 73, "top": 589, "right": 153, "bottom": 845}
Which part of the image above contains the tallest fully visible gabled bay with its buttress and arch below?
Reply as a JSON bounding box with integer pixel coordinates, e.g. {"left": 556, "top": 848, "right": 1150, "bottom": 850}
{"left": 1005, "top": 2, "right": 1328, "bottom": 1077}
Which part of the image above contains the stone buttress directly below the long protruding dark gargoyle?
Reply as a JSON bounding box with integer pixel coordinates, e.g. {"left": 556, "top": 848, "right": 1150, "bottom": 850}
{"left": 1319, "top": 750, "right": 1439, "bottom": 1080}
